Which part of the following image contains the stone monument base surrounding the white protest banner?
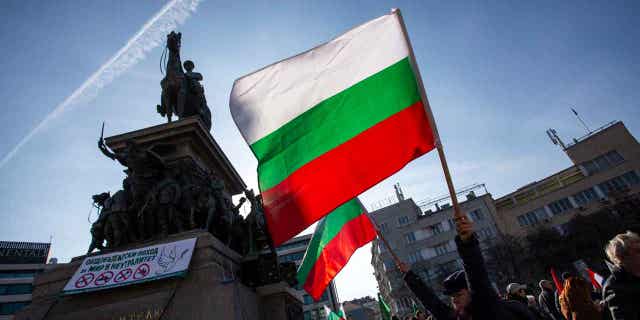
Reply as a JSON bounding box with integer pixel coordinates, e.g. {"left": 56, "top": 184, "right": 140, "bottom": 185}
{"left": 15, "top": 231, "right": 302, "bottom": 320}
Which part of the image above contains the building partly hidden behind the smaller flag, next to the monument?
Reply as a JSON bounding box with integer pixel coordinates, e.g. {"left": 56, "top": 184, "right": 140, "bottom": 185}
{"left": 277, "top": 234, "right": 340, "bottom": 320}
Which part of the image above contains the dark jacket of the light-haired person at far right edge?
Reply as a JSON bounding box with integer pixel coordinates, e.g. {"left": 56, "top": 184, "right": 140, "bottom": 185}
{"left": 602, "top": 268, "right": 640, "bottom": 320}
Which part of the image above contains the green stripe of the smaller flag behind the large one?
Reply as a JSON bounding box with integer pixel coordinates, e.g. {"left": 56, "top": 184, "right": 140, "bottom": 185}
{"left": 297, "top": 198, "right": 364, "bottom": 284}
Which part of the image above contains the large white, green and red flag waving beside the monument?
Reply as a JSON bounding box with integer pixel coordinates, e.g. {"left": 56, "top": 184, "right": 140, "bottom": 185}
{"left": 229, "top": 11, "right": 435, "bottom": 246}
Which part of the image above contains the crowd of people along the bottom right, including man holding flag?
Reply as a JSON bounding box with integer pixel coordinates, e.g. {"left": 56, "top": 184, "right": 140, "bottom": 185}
{"left": 392, "top": 215, "right": 640, "bottom": 320}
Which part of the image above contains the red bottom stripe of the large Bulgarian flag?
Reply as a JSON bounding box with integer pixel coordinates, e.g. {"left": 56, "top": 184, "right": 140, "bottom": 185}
{"left": 262, "top": 101, "right": 435, "bottom": 246}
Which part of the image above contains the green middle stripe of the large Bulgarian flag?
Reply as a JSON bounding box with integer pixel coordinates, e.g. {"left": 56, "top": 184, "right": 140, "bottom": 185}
{"left": 251, "top": 58, "right": 420, "bottom": 191}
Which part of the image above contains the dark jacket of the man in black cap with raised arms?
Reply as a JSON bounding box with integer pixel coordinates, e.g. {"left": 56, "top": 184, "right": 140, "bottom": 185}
{"left": 404, "top": 236, "right": 535, "bottom": 320}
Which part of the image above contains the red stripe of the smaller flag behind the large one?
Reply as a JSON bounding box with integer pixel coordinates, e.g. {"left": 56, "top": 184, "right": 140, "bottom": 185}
{"left": 303, "top": 214, "right": 376, "bottom": 301}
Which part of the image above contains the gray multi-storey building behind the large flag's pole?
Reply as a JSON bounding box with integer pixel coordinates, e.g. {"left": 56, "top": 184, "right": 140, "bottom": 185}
{"left": 371, "top": 185, "right": 500, "bottom": 316}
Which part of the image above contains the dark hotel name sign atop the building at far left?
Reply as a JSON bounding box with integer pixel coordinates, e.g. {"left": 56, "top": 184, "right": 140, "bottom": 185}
{"left": 0, "top": 241, "right": 51, "bottom": 264}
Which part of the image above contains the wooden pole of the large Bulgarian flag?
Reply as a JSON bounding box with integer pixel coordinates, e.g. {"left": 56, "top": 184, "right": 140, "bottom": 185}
{"left": 391, "top": 8, "right": 464, "bottom": 220}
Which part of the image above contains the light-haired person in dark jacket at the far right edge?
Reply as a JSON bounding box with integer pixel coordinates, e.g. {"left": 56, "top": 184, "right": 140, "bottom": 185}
{"left": 602, "top": 231, "right": 640, "bottom": 320}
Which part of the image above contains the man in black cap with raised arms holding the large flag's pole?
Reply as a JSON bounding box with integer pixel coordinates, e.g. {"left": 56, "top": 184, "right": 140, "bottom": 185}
{"left": 398, "top": 212, "right": 535, "bottom": 320}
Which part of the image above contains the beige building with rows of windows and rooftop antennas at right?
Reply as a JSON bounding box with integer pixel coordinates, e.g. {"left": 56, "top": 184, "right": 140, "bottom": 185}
{"left": 495, "top": 121, "right": 640, "bottom": 236}
